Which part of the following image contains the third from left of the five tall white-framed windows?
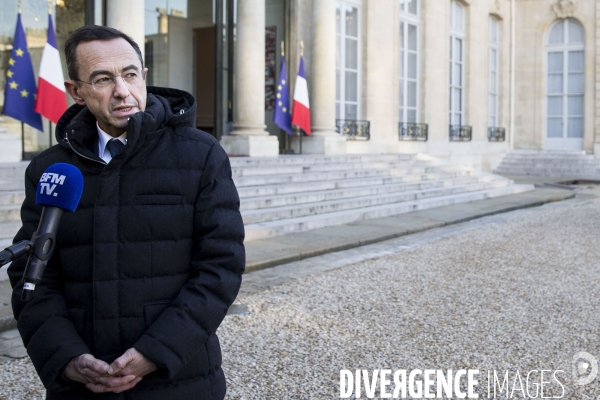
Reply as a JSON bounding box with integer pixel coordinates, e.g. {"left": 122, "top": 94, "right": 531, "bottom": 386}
{"left": 450, "top": 0, "right": 466, "bottom": 125}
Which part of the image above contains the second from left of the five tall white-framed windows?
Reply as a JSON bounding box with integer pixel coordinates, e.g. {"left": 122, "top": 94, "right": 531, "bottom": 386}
{"left": 399, "top": 0, "right": 420, "bottom": 122}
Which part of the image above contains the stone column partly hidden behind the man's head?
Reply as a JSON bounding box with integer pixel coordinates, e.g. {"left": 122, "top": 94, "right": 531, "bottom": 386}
{"left": 106, "top": 0, "right": 145, "bottom": 57}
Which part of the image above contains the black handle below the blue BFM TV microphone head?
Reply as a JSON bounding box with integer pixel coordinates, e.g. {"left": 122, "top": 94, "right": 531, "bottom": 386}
{"left": 21, "top": 207, "right": 64, "bottom": 301}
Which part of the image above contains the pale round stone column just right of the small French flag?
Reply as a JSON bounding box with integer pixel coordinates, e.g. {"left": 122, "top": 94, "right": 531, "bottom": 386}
{"left": 302, "top": 0, "right": 346, "bottom": 154}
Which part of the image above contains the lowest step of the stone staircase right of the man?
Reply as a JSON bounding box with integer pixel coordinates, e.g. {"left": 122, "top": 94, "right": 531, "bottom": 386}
{"left": 245, "top": 185, "right": 533, "bottom": 241}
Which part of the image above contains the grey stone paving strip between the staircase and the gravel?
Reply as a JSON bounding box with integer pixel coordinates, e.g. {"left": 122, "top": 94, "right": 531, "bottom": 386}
{"left": 0, "top": 183, "right": 575, "bottom": 362}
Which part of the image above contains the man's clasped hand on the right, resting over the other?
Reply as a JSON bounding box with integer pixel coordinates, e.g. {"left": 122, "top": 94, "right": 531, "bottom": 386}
{"left": 86, "top": 347, "right": 156, "bottom": 393}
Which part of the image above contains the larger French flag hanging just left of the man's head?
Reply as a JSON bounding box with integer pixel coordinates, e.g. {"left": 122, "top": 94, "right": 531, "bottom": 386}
{"left": 35, "top": 14, "right": 67, "bottom": 123}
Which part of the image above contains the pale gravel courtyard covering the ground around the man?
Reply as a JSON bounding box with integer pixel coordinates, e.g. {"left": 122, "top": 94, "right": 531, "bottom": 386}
{"left": 0, "top": 186, "right": 600, "bottom": 400}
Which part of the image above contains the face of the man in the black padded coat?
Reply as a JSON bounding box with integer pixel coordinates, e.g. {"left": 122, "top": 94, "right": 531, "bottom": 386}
{"left": 65, "top": 38, "right": 147, "bottom": 137}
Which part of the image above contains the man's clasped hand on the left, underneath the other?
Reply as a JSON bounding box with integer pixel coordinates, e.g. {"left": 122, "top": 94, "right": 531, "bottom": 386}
{"left": 64, "top": 354, "right": 141, "bottom": 393}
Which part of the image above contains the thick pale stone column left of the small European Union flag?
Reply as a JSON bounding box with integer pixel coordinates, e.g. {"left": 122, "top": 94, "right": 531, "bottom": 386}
{"left": 221, "top": 0, "right": 279, "bottom": 157}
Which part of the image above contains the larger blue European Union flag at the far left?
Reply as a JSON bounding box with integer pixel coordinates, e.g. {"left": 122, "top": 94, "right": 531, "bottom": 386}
{"left": 2, "top": 14, "right": 44, "bottom": 131}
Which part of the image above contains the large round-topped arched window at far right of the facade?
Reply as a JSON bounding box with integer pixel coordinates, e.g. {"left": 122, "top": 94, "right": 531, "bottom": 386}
{"left": 545, "top": 18, "right": 585, "bottom": 150}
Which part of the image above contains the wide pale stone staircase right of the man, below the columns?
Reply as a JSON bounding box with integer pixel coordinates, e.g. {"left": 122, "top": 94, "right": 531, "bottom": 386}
{"left": 231, "top": 154, "right": 533, "bottom": 241}
